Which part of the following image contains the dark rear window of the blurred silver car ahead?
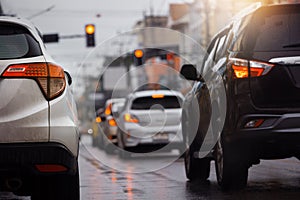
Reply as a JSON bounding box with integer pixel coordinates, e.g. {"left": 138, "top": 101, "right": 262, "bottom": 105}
{"left": 131, "top": 96, "right": 182, "bottom": 110}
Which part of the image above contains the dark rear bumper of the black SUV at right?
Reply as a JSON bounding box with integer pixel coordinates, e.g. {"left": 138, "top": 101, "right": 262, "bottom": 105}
{"left": 225, "top": 113, "right": 300, "bottom": 160}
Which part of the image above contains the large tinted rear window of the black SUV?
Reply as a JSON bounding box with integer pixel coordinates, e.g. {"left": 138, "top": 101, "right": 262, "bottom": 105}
{"left": 244, "top": 5, "right": 300, "bottom": 52}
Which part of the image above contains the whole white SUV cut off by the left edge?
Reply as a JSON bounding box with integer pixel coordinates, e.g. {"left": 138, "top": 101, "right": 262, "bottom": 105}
{"left": 0, "top": 17, "right": 79, "bottom": 199}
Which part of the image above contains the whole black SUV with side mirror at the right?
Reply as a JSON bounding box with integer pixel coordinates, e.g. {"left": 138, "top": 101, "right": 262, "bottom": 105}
{"left": 181, "top": 4, "right": 300, "bottom": 189}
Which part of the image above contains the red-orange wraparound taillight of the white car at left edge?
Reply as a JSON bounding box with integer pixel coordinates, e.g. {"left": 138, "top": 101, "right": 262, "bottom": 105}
{"left": 2, "top": 63, "right": 66, "bottom": 100}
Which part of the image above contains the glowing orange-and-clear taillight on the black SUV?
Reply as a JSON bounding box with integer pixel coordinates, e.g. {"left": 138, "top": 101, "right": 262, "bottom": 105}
{"left": 229, "top": 58, "right": 274, "bottom": 78}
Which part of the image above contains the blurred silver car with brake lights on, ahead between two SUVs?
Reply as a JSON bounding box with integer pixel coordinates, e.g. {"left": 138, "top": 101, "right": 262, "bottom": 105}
{"left": 117, "top": 90, "right": 183, "bottom": 156}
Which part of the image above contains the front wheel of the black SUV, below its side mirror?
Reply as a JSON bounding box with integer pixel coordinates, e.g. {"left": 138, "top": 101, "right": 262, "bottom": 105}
{"left": 184, "top": 143, "right": 210, "bottom": 181}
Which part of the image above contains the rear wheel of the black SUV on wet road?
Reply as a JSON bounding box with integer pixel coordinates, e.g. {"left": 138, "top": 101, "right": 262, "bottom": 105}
{"left": 215, "top": 139, "right": 248, "bottom": 190}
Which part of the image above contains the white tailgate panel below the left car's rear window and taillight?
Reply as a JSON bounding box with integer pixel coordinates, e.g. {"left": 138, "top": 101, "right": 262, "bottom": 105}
{"left": 0, "top": 79, "right": 49, "bottom": 143}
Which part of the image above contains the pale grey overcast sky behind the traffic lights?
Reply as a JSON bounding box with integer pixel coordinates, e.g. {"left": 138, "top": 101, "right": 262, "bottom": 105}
{"left": 0, "top": 0, "right": 190, "bottom": 64}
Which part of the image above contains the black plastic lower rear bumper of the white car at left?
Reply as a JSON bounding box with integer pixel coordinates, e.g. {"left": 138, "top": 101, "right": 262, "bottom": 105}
{"left": 0, "top": 142, "right": 78, "bottom": 175}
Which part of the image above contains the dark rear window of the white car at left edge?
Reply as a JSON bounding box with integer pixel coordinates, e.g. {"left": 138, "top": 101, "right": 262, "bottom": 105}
{"left": 0, "top": 23, "right": 42, "bottom": 59}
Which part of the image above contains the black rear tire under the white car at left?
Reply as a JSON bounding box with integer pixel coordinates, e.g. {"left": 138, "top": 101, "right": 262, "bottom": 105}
{"left": 31, "top": 165, "right": 80, "bottom": 200}
